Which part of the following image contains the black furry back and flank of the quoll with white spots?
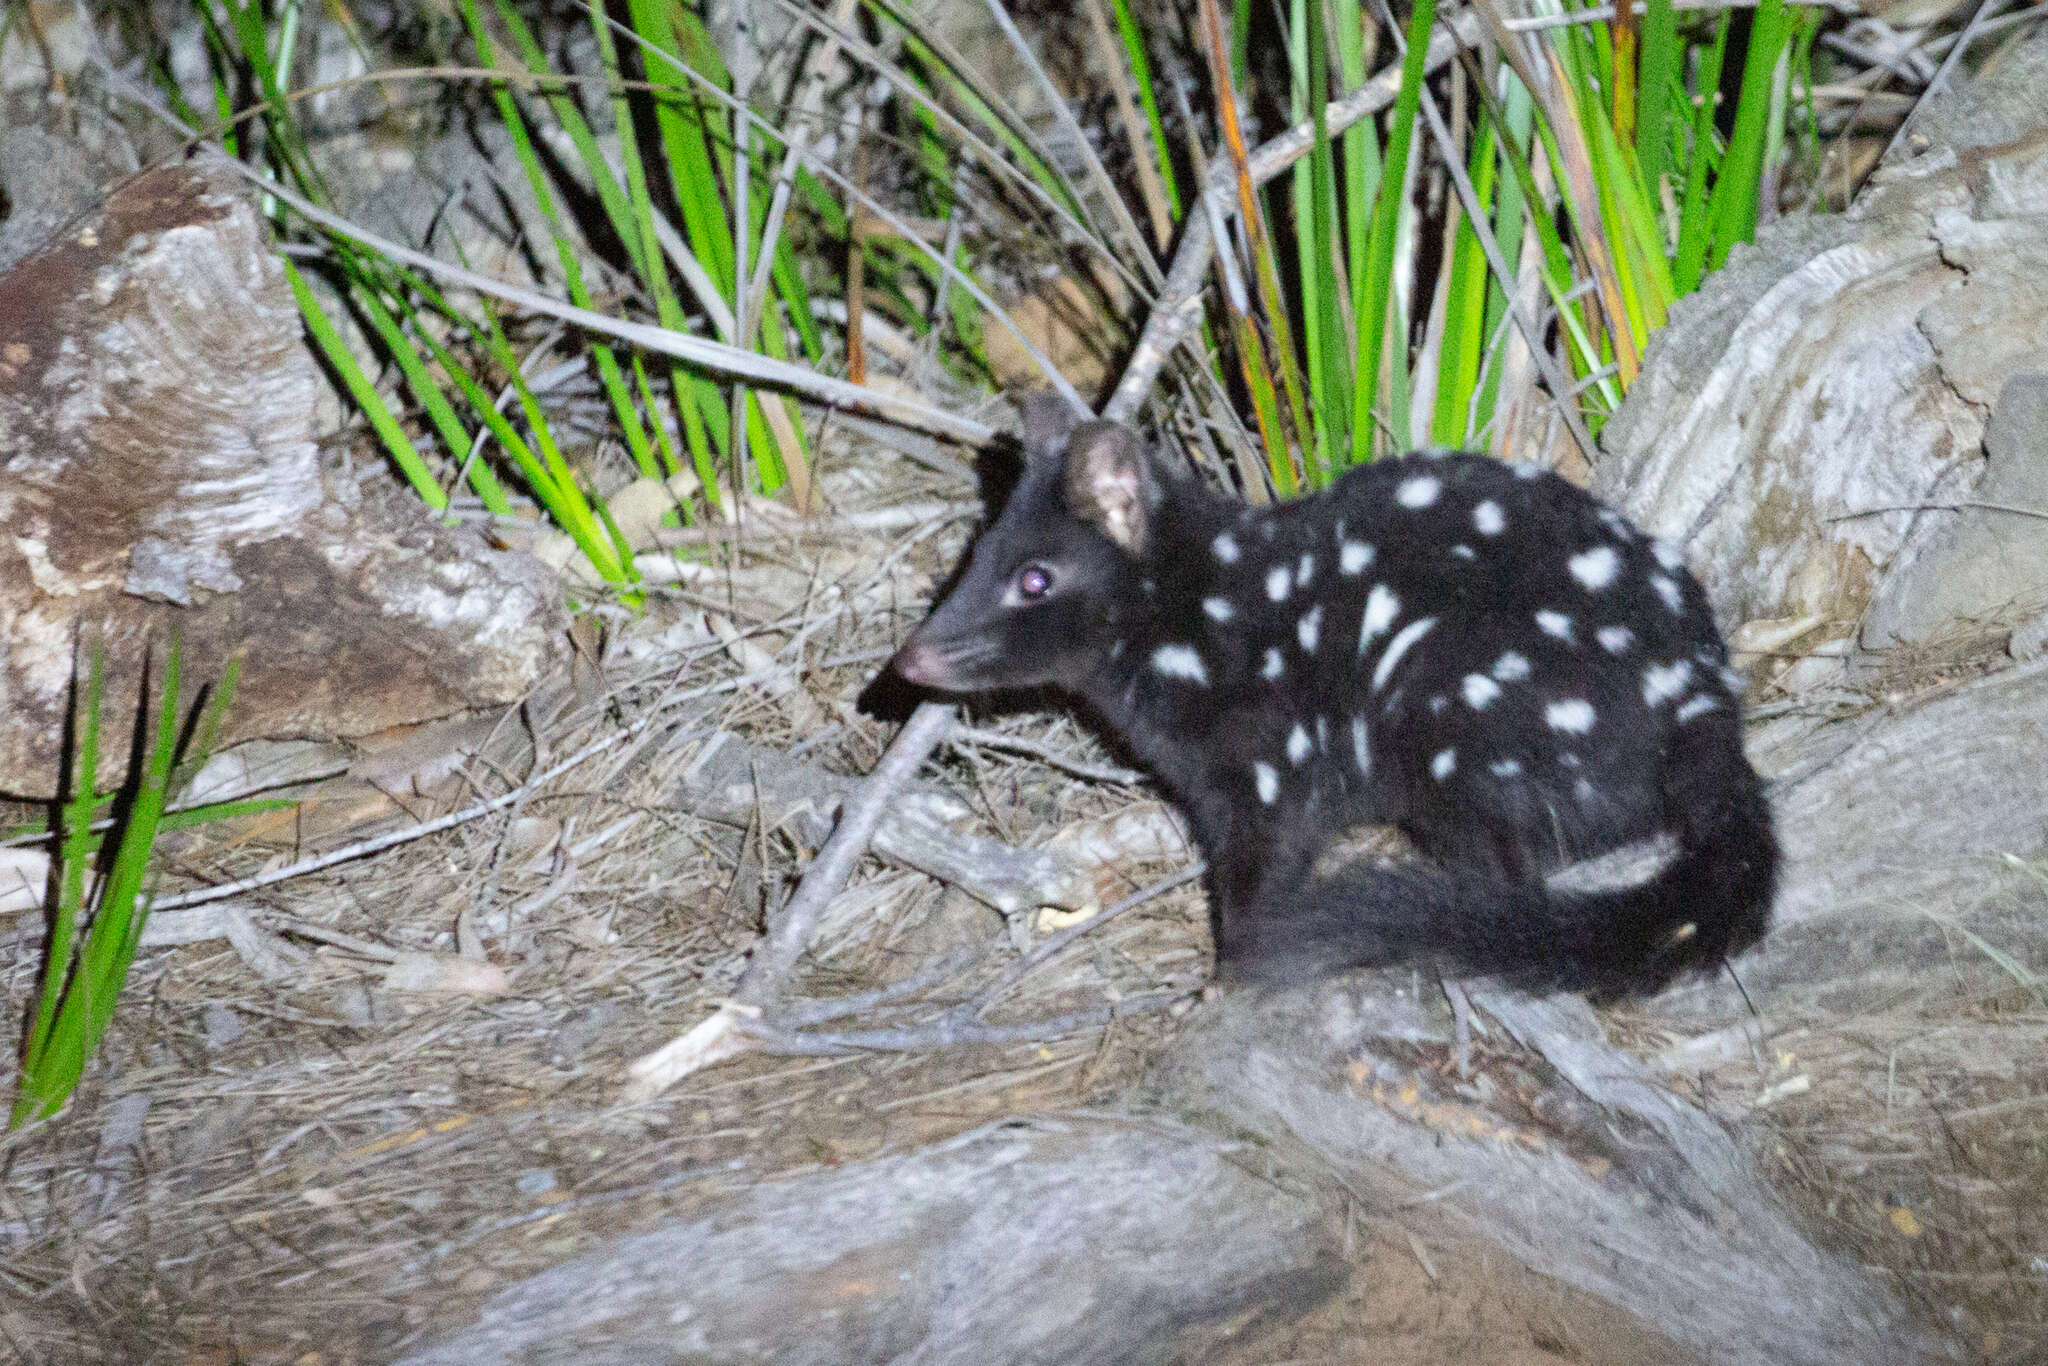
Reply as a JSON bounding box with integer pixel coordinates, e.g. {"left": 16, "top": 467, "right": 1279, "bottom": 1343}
{"left": 1192, "top": 455, "right": 1735, "bottom": 868}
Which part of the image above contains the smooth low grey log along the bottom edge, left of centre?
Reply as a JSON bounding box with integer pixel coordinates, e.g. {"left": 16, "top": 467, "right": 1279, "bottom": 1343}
{"left": 406, "top": 1116, "right": 1343, "bottom": 1366}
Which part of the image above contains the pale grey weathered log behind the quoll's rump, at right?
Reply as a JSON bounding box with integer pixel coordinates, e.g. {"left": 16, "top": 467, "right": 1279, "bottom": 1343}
{"left": 1595, "top": 37, "right": 2048, "bottom": 663}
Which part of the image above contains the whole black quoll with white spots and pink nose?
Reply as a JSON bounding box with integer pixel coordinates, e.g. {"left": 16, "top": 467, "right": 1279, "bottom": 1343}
{"left": 895, "top": 395, "right": 1778, "bottom": 995}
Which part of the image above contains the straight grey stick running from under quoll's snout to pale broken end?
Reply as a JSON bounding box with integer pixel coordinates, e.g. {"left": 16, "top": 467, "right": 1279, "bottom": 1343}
{"left": 627, "top": 702, "right": 952, "bottom": 1102}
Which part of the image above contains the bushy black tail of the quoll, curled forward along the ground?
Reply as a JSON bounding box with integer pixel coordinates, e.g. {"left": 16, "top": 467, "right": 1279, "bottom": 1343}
{"left": 1225, "top": 733, "right": 1778, "bottom": 997}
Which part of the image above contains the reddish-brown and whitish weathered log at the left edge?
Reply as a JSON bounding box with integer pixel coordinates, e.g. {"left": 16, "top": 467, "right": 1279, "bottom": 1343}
{"left": 0, "top": 150, "right": 563, "bottom": 797}
